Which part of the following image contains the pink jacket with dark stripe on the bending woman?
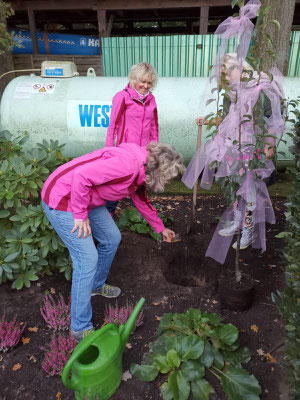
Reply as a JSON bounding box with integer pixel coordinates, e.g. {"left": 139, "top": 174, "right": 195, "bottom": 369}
{"left": 41, "top": 143, "right": 165, "bottom": 233}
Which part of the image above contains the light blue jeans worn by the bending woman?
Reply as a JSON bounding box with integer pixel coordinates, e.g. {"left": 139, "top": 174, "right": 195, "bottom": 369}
{"left": 43, "top": 202, "right": 121, "bottom": 332}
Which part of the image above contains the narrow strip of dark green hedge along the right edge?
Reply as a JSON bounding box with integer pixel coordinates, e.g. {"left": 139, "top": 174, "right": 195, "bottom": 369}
{"left": 274, "top": 103, "right": 300, "bottom": 399}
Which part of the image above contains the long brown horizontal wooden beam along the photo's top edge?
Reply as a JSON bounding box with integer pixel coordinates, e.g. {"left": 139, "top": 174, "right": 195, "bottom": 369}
{"left": 12, "top": 0, "right": 232, "bottom": 11}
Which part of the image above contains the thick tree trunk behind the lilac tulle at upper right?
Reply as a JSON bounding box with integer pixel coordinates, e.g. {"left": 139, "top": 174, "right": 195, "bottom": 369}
{"left": 256, "top": 0, "right": 296, "bottom": 76}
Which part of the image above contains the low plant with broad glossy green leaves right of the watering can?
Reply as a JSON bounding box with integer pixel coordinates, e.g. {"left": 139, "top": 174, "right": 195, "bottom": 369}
{"left": 130, "top": 308, "right": 261, "bottom": 400}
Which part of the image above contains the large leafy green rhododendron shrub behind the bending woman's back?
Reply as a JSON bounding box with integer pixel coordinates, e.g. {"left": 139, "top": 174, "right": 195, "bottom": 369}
{"left": 0, "top": 131, "right": 71, "bottom": 289}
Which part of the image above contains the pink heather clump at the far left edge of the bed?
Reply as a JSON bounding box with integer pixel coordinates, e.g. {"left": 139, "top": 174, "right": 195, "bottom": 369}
{"left": 0, "top": 315, "right": 25, "bottom": 353}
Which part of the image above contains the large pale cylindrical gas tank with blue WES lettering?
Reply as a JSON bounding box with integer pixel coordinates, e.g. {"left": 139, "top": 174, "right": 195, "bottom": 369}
{"left": 0, "top": 69, "right": 300, "bottom": 161}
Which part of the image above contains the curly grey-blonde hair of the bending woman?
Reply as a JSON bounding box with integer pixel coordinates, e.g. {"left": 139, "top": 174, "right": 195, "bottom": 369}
{"left": 145, "top": 142, "right": 185, "bottom": 193}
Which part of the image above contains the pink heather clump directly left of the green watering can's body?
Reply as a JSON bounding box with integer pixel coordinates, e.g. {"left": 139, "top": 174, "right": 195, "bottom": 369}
{"left": 40, "top": 334, "right": 78, "bottom": 376}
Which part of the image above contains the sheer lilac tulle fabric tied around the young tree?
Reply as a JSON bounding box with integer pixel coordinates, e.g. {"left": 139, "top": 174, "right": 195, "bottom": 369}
{"left": 182, "top": 0, "right": 285, "bottom": 263}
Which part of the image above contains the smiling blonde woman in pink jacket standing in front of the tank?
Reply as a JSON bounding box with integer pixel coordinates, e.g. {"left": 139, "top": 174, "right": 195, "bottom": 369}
{"left": 105, "top": 62, "right": 159, "bottom": 214}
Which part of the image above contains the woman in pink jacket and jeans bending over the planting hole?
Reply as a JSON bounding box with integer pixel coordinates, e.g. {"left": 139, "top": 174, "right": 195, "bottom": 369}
{"left": 41, "top": 143, "right": 185, "bottom": 341}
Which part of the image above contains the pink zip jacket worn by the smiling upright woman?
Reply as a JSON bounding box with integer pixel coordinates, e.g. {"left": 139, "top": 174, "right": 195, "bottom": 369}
{"left": 105, "top": 84, "right": 159, "bottom": 147}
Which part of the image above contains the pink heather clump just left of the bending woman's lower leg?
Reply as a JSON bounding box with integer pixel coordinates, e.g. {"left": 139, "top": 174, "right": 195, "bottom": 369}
{"left": 40, "top": 294, "right": 71, "bottom": 331}
